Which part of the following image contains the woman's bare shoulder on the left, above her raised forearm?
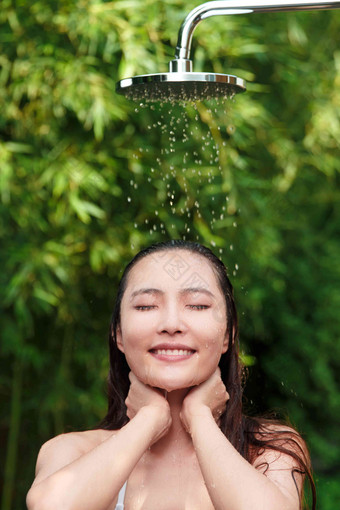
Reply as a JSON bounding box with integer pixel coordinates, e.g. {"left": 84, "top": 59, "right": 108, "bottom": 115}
{"left": 33, "top": 429, "right": 115, "bottom": 485}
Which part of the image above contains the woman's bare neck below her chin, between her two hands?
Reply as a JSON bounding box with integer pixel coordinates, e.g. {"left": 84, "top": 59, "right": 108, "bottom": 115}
{"left": 151, "top": 388, "right": 193, "bottom": 455}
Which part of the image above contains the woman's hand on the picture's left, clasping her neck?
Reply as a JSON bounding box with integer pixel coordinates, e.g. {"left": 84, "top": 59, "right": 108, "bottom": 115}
{"left": 125, "top": 372, "right": 172, "bottom": 446}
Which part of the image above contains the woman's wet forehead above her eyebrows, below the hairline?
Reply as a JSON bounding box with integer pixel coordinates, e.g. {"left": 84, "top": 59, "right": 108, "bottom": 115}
{"left": 126, "top": 249, "right": 221, "bottom": 294}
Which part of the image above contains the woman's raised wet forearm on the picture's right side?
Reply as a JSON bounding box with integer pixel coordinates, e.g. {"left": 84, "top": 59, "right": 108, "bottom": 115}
{"left": 191, "top": 408, "right": 293, "bottom": 510}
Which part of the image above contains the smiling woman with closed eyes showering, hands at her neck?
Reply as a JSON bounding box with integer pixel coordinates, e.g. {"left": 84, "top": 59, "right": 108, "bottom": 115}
{"left": 27, "top": 241, "right": 315, "bottom": 510}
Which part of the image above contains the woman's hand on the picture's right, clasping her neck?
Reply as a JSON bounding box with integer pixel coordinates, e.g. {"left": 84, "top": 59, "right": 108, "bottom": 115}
{"left": 180, "top": 367, "right": 229, "bottom": 434}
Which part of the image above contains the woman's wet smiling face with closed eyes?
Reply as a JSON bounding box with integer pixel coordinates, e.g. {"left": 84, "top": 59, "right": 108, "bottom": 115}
{"left": 117, "top": 250, "right": 228, "bottom": 391}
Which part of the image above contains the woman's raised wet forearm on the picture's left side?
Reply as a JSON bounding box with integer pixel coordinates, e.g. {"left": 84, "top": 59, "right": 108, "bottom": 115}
{"left": 28, "top": 408, "right": 156, "bottom": 510}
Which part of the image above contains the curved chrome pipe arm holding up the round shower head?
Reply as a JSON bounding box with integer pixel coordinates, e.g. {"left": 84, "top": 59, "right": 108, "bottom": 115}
{"left": 170, "top": 0, "right": 340, "bottom": 66}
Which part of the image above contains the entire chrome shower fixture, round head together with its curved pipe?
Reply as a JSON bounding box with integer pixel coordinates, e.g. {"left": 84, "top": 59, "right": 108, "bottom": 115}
{"left": 116, "top": 0, "right": 340, "bottom": 101}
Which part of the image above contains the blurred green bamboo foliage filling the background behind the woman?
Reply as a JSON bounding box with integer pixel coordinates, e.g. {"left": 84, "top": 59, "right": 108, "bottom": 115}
{"left": 0, "top": 0, "right": 340, "bottom": 510}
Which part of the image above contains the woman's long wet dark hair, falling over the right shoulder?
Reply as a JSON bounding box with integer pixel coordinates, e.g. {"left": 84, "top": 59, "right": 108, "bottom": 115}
{"left": 99, "top": 240, "right": 316, "bottom": 510}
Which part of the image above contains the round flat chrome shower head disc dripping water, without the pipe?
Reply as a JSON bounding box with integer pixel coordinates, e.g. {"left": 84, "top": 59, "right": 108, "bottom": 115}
{"left": 116, "top": 72, "right": 246, "bottom": 102}
